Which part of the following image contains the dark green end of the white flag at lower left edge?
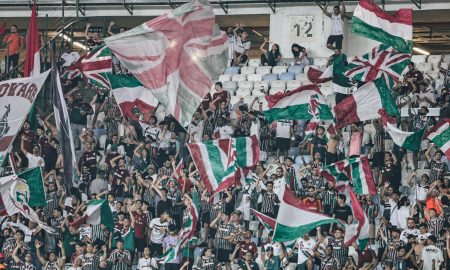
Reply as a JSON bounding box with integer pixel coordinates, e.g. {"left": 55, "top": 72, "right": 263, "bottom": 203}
{"left": 17, "top": 167, "right": 46, "bottom": 207}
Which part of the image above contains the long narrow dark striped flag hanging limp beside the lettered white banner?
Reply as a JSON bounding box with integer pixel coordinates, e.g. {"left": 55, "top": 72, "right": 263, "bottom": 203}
{"left": 51, "top": 48, "right": 77, "bottom": 190}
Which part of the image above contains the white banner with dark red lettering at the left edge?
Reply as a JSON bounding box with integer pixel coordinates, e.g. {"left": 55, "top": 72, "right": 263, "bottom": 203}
{"left": 0, "top": 71, "right": 50, "bottom": 164}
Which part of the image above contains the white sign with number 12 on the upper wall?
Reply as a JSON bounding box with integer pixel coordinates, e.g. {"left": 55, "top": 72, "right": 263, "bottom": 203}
{"left": 289, "top": 16, "right": 317, "bottom": 43}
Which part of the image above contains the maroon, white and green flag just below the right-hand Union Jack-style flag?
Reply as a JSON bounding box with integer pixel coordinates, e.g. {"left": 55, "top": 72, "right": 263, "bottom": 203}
{"left": 333, "top": 78, "right": 400, "bottom": 128}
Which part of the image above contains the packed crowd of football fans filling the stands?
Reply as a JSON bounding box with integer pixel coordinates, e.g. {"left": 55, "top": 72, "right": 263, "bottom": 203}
{"left": 0, "top": 2, "right": 450, "bottom": 270}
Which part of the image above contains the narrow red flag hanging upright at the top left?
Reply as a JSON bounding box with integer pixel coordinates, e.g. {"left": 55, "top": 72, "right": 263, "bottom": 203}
{"left": 24, "top": 0, "right": 41, "bottom": 77}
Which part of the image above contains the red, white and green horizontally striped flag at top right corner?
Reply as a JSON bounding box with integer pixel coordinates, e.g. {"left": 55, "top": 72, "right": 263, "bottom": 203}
{"left": 352, "top": 0, "right": 413, "bottom": 54}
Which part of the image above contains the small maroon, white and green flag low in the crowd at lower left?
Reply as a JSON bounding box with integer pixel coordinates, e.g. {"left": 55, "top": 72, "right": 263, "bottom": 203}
{"left": 70, "top": 200, "right": 114, "bottom": 231}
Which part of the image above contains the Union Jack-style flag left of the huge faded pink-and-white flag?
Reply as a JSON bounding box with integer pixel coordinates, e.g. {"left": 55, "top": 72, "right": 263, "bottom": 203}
{"left": 81, "top": 45, "right": 112, "bottom": 89}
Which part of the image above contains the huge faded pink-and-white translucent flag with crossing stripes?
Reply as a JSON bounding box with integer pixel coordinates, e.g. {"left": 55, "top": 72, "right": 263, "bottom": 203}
{"left": 105, "top": 0, "right": 228, "bottom": 126}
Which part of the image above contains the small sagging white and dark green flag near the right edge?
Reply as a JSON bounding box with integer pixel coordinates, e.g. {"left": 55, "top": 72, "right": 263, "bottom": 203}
{"left": 381, "top": 109, "right": 426, "bottom": 152}
